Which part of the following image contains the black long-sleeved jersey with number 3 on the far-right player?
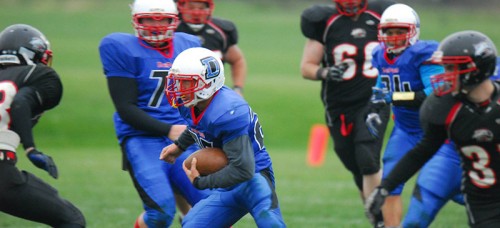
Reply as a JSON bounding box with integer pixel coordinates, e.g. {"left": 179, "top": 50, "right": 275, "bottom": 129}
{"left": 383, "top": 82, "right": 500, "bottom": 202}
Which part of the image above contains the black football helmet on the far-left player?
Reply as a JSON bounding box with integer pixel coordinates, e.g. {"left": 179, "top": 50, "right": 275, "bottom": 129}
{"left": 0, "top": 24, "right": 52, "bottom": 65}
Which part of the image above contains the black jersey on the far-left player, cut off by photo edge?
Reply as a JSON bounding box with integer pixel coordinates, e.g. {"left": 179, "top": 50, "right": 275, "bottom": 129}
{"left": 0, "top": 64, "right": 62, "bottom": 148}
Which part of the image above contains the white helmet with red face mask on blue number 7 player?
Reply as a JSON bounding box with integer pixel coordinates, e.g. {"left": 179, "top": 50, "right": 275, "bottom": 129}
{"left": 130, "top": 0, "right": 179, "bottom": 50}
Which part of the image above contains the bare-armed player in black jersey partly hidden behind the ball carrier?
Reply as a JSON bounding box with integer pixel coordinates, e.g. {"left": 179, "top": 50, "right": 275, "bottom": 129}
{"left": 176, "top": 0, "right": 247, "bottom": 95}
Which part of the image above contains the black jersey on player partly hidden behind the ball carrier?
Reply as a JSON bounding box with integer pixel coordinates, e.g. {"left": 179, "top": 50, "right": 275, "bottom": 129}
{"left": 176, "top": 17, "right": 238, "bottom": 61}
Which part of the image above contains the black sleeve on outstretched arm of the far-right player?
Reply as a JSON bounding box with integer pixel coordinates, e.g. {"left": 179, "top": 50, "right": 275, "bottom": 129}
{"left": 381, "top": 124, "right": 448, "bottom": 191}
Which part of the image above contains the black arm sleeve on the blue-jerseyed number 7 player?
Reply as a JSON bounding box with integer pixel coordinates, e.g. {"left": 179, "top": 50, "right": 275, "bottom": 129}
{"left": 108, "top": 77, "right": 172, "bottom": 136}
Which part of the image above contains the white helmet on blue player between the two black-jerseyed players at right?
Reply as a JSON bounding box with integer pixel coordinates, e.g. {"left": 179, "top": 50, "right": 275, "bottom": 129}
{"left": 378, "top": 4, "right": 420, "bottom": 54}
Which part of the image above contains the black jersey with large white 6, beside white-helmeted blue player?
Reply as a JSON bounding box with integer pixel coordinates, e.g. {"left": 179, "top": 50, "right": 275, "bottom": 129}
{"left": 301, "top": 0, "right": 394, "bottom": 113}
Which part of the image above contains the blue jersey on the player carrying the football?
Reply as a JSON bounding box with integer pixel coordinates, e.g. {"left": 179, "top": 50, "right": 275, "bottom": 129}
{"left": 179, "top": 86, "right": 272, "bottom": 173}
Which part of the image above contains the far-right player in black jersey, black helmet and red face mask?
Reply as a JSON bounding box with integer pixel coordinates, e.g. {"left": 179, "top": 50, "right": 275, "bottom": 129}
{"left": 366, "top": 31, "right": 500, "bottom": 227}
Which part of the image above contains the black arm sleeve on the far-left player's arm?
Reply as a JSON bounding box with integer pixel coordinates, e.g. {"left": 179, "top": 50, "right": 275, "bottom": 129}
{"left": 10, "top": 87, "right": 40, "bottom": 149}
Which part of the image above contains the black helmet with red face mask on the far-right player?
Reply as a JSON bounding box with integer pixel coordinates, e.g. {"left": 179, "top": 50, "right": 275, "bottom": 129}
{"left": 431, "top": 31, "right": 497, "bottom": 96}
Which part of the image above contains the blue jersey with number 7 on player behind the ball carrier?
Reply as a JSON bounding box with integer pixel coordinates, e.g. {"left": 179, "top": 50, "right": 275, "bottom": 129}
{"left": 99, "top": 33, "right": 200, "bottom": 141}
